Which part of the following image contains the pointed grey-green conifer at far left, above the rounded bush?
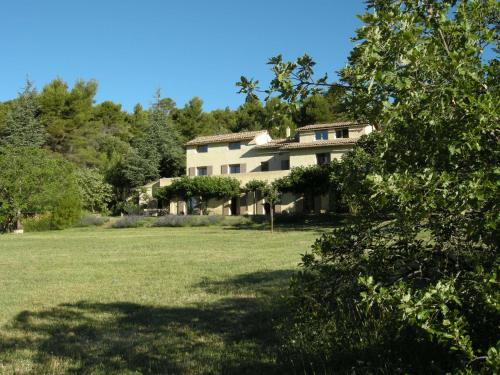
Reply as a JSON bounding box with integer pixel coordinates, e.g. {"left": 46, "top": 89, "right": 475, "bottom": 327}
{"left": 0, "top": 80, "right": 46, "bottom": 147}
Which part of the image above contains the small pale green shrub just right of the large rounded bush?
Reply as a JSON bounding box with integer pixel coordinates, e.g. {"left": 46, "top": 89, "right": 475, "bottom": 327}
{"left": 76, "top": 168, "right": 113, "bottom": 213}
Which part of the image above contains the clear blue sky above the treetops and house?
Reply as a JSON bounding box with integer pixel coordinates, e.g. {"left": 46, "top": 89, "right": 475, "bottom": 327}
{"left": 0, "top": 0, "right": 364, "bottom": 110}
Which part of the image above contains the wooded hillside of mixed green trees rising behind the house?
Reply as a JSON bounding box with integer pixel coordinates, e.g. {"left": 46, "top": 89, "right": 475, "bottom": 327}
{"left": 0, "top": 78, "right": 345, "bottom": 225}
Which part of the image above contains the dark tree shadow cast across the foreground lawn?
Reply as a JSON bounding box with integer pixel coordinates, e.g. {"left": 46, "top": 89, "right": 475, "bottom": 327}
{"left": 0, "top": 271, "right": 292, "bottom": 374}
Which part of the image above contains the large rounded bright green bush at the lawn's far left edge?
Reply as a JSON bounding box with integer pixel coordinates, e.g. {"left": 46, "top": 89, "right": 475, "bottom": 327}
{"left": 0, "top": 147, "right": 81, "bottom": 231}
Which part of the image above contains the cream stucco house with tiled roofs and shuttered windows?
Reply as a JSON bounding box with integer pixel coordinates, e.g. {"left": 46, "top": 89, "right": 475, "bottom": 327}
{"left": 145, "top": 122, "right": 373, "bottom": 215}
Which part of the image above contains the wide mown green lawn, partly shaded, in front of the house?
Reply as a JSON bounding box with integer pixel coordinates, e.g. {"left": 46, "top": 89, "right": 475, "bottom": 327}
{"left": 0, "top": 227, "right": 319, "bottom": 374}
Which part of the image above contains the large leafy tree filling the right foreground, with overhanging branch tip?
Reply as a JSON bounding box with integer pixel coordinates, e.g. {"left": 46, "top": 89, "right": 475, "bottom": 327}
{"left": 247, "top": 0, "right": 500, "bottom": 373}
